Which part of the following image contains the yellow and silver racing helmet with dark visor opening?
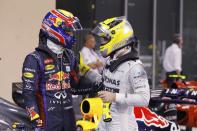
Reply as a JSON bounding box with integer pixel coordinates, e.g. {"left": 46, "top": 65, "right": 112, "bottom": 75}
{"left": 92, "top": 17, "right": 137, "bottom": 57}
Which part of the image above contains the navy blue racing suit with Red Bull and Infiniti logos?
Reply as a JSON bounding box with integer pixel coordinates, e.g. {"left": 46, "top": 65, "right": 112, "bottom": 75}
{"left": 22, "top": 45, "right": 97, "bottom": 131}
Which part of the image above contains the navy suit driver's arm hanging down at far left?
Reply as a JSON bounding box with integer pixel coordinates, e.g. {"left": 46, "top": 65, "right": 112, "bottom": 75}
{"left": 22, "top": 54, "right": 39, "bottom": 126}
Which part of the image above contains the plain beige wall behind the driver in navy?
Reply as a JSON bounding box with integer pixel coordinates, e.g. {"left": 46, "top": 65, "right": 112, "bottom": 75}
{"left": 0, "top": 0, "right": 55, "bottom": 101}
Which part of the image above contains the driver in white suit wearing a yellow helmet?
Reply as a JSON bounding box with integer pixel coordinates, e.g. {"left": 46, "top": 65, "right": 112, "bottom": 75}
{"left": 92, "top": 17, "right": 150, "bottom": 131}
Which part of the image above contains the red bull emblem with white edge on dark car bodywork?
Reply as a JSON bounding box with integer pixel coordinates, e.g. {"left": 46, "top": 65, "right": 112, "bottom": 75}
{"left": 134, "top": 107, "right": 169, "bottom": 128}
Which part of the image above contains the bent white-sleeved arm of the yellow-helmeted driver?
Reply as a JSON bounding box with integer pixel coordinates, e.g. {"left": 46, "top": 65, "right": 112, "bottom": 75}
{"left": 115, "top": 64, "right": 150, "bottom": 106}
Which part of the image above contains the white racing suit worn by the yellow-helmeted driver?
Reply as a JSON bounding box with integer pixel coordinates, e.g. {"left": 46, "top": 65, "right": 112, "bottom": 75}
{"left": 98, "top": 60, "right": 150, "bottom": 131}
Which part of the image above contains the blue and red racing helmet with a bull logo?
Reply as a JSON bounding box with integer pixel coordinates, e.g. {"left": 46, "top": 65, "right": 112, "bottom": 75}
{"left": 41, "top": 9, "right": 82, "bottom": 49}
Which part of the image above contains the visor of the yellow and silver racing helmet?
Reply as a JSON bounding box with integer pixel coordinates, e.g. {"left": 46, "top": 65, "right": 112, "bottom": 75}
{"left": 92, "top": 24, "right": 110, "bottom": 45}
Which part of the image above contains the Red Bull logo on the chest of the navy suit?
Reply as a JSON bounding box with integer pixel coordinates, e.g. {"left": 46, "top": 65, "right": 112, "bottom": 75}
{"left": 46, "top": 71, "right": 70, "bottom": 90}
